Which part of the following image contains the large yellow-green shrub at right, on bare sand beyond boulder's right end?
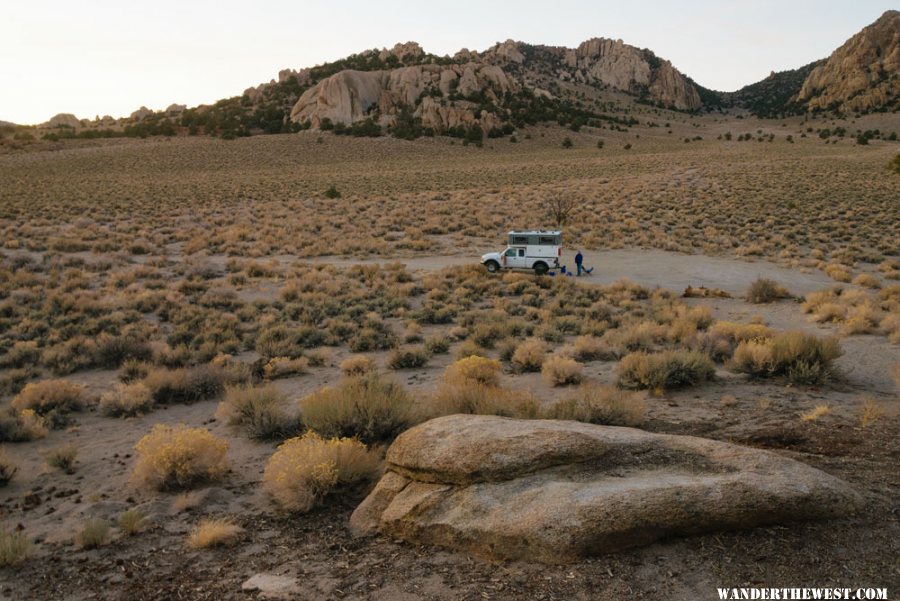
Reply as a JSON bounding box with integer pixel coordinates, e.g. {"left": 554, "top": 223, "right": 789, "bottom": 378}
{"left": 731, "top": 331, "right": 842, "bottom": 384}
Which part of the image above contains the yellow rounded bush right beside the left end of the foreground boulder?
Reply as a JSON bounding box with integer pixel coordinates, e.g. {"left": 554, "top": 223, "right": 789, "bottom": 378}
{"left": 263, "top": 432, "right": 380, "bottom": 513}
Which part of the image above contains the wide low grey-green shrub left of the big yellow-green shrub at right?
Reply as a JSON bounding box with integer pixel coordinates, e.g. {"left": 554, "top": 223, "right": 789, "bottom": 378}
{"left": 617, "top": 350, "right": 715, "bottom": 391}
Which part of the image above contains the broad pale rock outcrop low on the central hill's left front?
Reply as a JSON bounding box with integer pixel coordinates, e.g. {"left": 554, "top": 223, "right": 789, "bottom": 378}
{"left": 291, "top": 63, "right": 518, "bottom": 130}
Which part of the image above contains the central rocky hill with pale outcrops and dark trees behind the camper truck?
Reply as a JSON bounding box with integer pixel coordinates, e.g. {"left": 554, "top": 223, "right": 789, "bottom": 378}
{"left": 284, "top": 38, "right": 702, "bottom": 132}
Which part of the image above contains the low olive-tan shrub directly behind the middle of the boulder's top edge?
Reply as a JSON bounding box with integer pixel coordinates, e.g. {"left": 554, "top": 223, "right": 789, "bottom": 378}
{"left": 542, "top": 384, "right": 647, "bottom": 426}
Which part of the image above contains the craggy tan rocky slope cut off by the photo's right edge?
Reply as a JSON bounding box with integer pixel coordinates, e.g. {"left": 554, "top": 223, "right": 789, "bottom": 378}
{"left": 794, "top": 10, "right": 900, "bottom": 111}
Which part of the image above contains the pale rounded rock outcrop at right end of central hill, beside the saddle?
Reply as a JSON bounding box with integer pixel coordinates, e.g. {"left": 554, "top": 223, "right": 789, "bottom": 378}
{"left": 565, "top": 38, "right": 702, "bottom": 110}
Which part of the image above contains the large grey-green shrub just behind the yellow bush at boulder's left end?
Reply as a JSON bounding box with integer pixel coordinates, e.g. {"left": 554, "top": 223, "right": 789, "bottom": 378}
{"left": 300, "top": 372, "right": 415, "bottom": 444}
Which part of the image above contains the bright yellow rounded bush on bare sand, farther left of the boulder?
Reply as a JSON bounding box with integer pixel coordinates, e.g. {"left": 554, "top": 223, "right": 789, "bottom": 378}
{"left": 132, "top": 424, "right": 228, "bottom": 490}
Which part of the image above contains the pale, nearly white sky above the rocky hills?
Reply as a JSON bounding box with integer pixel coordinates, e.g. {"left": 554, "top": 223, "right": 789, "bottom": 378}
{"left": 0, "top": 0, "right": 896, "bottom": 124}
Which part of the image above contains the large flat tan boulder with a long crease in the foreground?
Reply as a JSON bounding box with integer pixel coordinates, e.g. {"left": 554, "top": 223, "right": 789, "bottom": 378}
{"left": 350, "top": 415, "right": 862, "bottom": 563}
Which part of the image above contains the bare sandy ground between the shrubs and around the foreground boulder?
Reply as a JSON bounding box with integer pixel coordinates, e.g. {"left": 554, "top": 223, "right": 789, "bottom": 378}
{"left": 0, "top": 250, "right": 900, "bottom": 601}
